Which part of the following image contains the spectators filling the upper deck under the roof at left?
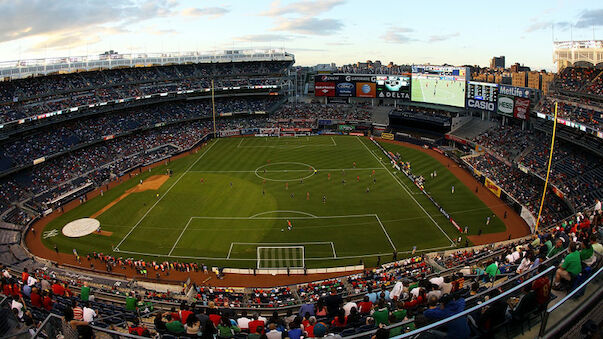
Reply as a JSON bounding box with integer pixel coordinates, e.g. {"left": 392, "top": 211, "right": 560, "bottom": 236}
{"left": 0, "top": 62, "right": 290, "bottom": 122}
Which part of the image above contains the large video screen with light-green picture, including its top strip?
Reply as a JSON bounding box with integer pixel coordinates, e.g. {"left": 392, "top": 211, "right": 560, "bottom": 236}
{"left": 411, "top": 65, "right": 469, "bottom": 107}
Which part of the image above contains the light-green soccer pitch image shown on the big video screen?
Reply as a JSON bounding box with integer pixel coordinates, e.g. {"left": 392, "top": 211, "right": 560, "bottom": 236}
{"left": 411, "top": 78, "right": 465, "bottom": 107}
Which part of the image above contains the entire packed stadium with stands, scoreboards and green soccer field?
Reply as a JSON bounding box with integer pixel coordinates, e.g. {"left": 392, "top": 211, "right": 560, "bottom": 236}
{"left": 0, "top": 4, "right": 603, "bottom": 339}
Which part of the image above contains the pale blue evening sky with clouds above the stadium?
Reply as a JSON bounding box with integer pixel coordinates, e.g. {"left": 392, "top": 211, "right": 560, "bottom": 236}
{"left": 0, "top": 0, "right": 603, "bottom": 70}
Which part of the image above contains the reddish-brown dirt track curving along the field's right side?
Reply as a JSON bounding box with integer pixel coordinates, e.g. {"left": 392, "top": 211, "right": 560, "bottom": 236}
{"left": 375, "top": 138, "right": 530, "bottom": 245}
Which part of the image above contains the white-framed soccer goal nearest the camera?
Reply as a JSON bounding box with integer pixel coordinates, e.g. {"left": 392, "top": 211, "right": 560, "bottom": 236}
{"left": 257, "top": 246, "right": 305, "bottom": 268}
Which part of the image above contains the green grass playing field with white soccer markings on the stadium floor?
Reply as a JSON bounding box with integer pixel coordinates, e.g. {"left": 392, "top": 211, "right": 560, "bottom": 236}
{"left": 43, "top": 136, "right": 504, "bottom": 268}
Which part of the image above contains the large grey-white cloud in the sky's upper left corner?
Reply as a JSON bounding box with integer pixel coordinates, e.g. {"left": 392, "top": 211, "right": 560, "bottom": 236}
{"left": 0, "top": 0, "right": 175, "bottom": 45}
